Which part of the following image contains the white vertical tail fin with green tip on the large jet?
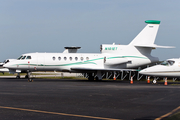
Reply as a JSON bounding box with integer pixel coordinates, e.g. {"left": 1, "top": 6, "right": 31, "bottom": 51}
{"left": 129, "top": 20, "right": 160, "bottom": 46}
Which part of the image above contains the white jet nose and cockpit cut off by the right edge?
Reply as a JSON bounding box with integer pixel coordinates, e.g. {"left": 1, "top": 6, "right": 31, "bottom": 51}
{"left": 139, "top": 58, "right": 180, "bottom": 77}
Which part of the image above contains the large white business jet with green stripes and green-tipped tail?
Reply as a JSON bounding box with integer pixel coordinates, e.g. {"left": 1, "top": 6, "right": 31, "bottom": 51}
{"left": 4, "top": 20, "right": 172, "bottom": 81}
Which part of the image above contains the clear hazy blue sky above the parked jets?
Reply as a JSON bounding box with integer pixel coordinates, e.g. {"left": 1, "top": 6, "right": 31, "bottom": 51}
{"left": 0, "top": 0, "right": 180, "bottom": 61}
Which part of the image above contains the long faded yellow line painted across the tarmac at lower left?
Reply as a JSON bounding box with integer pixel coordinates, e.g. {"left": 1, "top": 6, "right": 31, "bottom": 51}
{"left": 0, "top": 106, "right": 121, "bottom": 120}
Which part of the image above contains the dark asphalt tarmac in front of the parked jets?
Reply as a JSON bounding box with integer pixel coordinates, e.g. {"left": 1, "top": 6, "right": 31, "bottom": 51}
{"left": 0, "top": 78, "right": 180, "bottom": 120}
